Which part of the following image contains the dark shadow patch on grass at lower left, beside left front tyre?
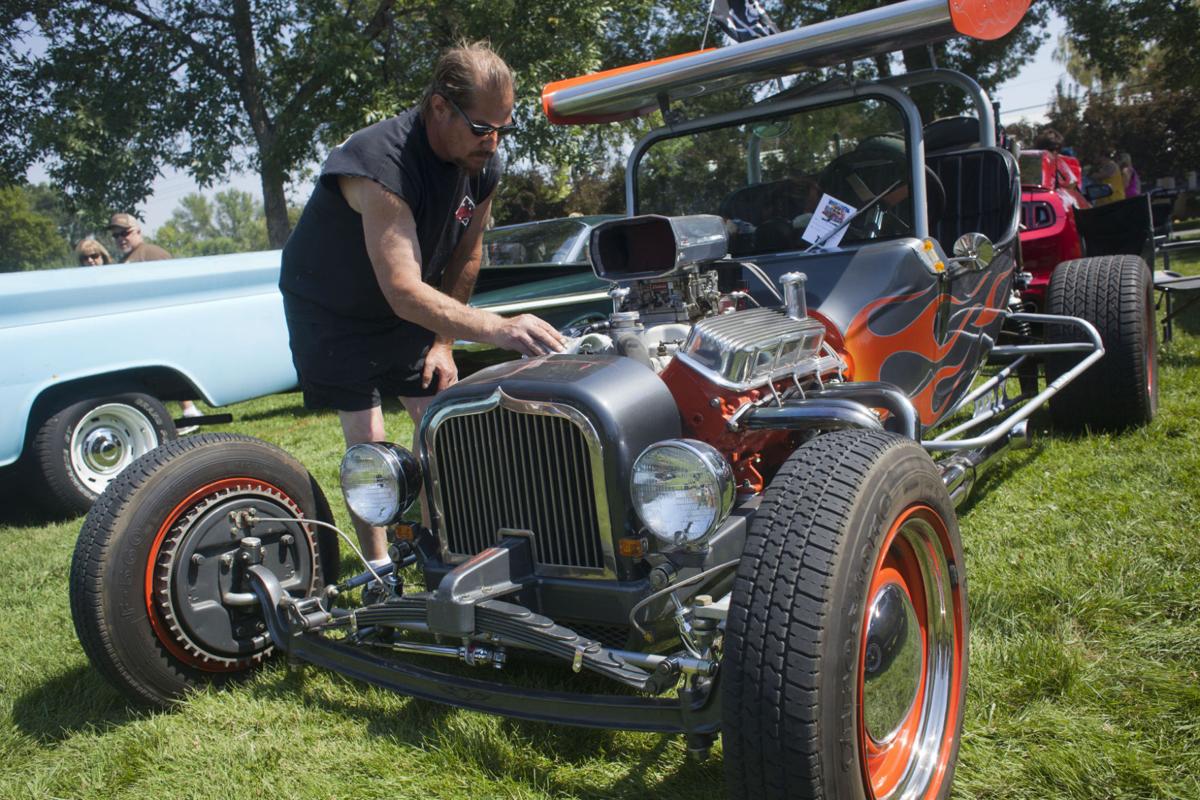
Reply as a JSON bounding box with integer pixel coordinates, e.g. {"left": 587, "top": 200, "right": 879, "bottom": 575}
{"left": 12, "top": 667, "right": 141, "bottom": 744}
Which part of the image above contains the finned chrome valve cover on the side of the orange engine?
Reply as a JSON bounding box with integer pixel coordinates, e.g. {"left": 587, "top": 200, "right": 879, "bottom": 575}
{"left": 676, "top": 308, "right": 824, "bottom": 391}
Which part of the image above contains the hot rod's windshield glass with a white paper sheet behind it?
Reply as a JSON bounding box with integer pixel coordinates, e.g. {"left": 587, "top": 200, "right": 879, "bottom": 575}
{"left": 636, "top": 100, "right": 913, "bottom": 255}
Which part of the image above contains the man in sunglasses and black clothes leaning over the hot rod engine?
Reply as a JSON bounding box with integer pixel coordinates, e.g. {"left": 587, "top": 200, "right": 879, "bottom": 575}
{"left": 280, "top": 42, "right": 563, "bottom": 575}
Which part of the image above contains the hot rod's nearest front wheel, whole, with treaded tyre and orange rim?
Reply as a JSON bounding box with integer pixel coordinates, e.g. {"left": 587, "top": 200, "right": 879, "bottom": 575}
{"left": 721, "top": 431, "right": 967, "bottom": 800}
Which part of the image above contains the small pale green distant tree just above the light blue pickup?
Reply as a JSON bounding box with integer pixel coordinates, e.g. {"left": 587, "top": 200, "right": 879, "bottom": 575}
{"left": 155, "top": 190, "right": 270, "bottom": 258}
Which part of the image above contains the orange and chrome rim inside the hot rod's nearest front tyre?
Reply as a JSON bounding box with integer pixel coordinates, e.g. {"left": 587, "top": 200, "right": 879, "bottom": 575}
{"left": 857, "top": 505, "right": 965, "bottom": 800}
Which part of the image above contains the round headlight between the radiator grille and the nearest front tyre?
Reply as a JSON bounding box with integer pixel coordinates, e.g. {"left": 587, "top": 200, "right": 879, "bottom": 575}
{"left": 630, "top": 439, "right": 733, "bottom": 547}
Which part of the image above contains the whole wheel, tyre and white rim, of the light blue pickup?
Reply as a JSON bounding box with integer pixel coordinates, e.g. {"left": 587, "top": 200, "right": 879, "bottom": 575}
{"left": 32, "top": 392, "right": 175, "bottom": 513}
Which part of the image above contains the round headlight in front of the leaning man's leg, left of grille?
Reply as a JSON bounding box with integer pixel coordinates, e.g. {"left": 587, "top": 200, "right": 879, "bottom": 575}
{"left": 341, "top": 441, "right": 421, "bottom": 525}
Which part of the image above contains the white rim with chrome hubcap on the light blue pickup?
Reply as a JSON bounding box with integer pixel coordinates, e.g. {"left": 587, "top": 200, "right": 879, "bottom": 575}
{"left": 70, "top": 403, "right": 158, "bottom": 494}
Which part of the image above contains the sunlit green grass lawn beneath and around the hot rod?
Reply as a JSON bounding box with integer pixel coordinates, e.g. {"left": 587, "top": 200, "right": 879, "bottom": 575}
{"left": 0, "top": 259, "right": 1200, "bottom": 800}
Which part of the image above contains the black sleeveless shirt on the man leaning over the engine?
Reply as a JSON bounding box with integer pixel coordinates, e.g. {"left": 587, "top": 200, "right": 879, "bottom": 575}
{"left": 280, "top": 108, "right": 503, "bottom": 321}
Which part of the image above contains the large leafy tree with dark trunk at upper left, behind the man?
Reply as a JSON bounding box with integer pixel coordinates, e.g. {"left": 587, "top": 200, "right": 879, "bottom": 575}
{"left": 0, "top": 0, "right": 405, "bottom": 243}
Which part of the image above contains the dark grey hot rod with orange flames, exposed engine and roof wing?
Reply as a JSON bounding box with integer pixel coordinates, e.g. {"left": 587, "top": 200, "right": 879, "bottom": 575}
{"left": 71, "top": 0, "right": 1156, "bottom": 798}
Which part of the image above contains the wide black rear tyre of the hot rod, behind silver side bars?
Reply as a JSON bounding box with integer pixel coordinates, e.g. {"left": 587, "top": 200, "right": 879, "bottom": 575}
{"left": 1046, "top": 255, "right": 1158, "bottom": 431}
